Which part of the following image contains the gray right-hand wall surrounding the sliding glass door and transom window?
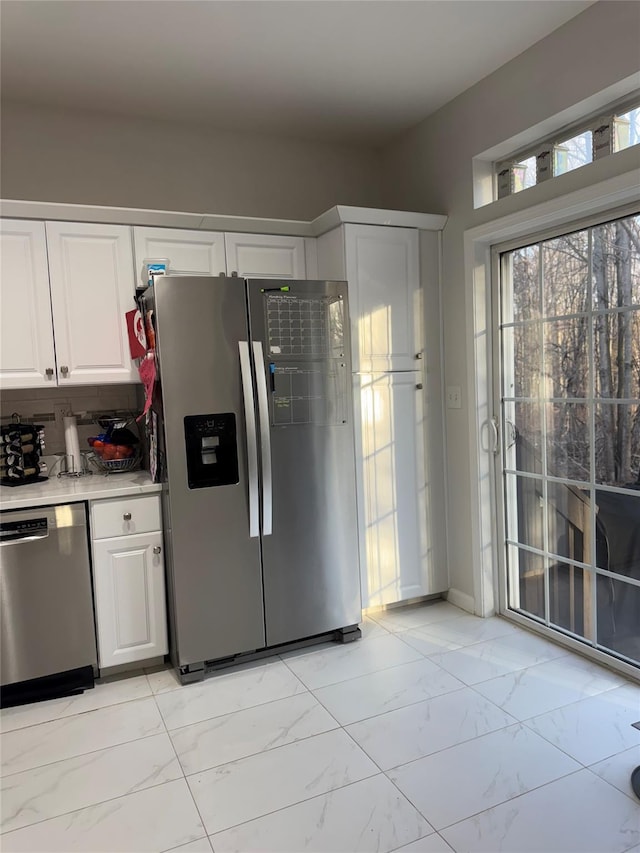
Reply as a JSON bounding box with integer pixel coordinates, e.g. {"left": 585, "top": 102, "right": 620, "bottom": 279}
{"left": 384, "top": 0, "right": 640, "bottom": 596}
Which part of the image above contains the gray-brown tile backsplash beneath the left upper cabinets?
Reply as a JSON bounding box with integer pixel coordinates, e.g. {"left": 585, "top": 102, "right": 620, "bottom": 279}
{"left": 0, "top": 385, "right": 142, "bottom": 455}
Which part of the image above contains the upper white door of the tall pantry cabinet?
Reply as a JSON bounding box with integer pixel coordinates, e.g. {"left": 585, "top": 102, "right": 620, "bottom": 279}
{"left": 344, "top": 225, "right": 423, "bottom": 373}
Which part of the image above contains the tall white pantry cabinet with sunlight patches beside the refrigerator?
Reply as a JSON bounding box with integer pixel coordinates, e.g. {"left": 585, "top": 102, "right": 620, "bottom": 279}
{"left": 317, "top": 224, "right": 448, "bottom": 608}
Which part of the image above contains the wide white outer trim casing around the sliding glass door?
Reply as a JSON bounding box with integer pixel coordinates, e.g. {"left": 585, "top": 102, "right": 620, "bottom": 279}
{"left": 460, "top": 170, "right": 640, "bottom": 680}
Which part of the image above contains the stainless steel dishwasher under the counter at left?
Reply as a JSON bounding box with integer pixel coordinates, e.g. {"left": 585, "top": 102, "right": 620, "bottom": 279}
{"left": 0, "top": 503, "right": 97, "bottom": 706}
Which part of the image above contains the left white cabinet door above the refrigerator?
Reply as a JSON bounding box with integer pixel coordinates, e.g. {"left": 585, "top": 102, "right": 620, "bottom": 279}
{"left": 133, "top": 228, "right": 227, "bottom": 286}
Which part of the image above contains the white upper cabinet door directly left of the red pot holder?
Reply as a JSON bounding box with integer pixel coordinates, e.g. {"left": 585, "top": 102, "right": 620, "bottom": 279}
{"left": 47, "top": 222, "right": 139, "bottom": 386}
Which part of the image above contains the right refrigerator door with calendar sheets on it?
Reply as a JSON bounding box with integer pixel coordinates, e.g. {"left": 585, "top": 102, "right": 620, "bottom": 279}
{"left": 248, "top": 280, "right": 361, "bottom": 645}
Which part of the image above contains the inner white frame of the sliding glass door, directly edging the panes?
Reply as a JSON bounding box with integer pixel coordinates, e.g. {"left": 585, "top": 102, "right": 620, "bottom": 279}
{"left": 487, "top": 202, "right": 640, "bottom": 679}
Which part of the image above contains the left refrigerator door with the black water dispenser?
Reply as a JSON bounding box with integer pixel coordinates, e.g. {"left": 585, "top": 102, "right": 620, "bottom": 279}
{"left": 155, "top": 276, "right": 265, "bottom": 666}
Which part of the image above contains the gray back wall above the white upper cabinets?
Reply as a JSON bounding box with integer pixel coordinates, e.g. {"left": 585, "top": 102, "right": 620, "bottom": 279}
{"left": 0, "top": 103, "right": 381, "bottom": 220}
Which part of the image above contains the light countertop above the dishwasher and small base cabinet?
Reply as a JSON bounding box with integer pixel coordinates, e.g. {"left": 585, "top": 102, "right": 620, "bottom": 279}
{"left": 0, "top": 471, "right": 162, "bottom": 510}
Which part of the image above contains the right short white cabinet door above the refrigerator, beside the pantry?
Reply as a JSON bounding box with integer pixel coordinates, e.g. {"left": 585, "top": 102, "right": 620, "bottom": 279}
{"left": 224, "top": 234, "right": 306, "bottom": 279}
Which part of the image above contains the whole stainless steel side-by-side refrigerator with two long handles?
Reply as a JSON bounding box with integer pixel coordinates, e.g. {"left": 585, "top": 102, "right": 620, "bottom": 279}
{"left": 142, "top": 276, "right": 361, "bottom": 682}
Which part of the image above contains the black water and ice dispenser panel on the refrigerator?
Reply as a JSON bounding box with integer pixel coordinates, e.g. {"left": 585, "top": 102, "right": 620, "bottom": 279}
{"left": 184, "top": 412, "right": 239, "bottom": 489}
